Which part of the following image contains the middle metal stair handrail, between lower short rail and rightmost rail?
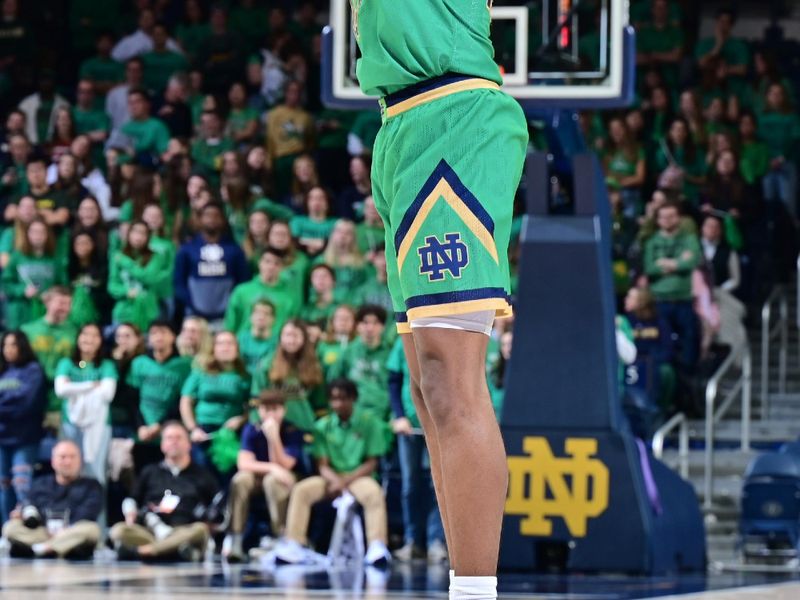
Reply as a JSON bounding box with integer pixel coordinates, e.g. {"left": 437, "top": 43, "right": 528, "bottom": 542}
{"left": 703, "top": 343, "right": 753, "bottom": 510}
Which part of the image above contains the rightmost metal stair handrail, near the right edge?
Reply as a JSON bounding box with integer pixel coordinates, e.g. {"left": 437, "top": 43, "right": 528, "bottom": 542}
{"left": 761, "top": 284, "right": 788, "bottom": 419}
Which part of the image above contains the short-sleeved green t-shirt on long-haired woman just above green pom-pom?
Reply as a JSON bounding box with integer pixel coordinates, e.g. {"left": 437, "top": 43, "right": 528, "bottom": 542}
{"left": 181, "top": 369, "right": 250, "bottom": 426}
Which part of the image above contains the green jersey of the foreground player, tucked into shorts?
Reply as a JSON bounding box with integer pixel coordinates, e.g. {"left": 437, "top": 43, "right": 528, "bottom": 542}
{"left": 351, "top": 0, "right": 502, "bottom": 96}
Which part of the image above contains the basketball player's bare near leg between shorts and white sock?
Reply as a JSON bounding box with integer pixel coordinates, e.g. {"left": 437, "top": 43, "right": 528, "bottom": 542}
{"left": 404, "top": 327, "right": 508, "bottom": 577}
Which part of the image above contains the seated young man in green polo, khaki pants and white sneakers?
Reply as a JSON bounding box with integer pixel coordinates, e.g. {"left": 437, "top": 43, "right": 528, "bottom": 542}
{"left": 276, "top": 379, "right": 391, "bottom": 565}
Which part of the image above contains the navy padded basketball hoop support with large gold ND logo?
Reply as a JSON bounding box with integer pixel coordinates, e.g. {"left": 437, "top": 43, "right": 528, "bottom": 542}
{"left": 500, "top": 145, "right": 705, "bottom": 574}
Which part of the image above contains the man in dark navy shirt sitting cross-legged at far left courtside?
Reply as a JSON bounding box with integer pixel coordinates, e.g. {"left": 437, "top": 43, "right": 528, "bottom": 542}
{"left": 3, "top": 440, "right": 103, "bottom": 560}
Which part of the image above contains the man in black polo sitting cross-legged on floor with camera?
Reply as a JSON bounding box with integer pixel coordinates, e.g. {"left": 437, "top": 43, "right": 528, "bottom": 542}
{"left": 109, "top": 421, "right": 219, "bottom": 561}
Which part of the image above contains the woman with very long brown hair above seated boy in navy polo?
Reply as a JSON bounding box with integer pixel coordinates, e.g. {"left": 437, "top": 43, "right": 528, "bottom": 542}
{"left": 250, "top": 319, "right": 327, "bottom": 431}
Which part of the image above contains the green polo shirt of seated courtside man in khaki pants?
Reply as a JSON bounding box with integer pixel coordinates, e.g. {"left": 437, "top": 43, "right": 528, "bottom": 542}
{"left": 312, "top": 409, "right": 387, "bottom": 473}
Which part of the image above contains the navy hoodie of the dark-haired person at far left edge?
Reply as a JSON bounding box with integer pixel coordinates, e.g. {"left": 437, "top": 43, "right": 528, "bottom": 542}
{"left": 0, "top": 360, "right": 47, "bottom": 446}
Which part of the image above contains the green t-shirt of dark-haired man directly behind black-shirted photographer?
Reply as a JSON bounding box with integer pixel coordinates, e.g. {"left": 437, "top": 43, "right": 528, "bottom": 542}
{"left": 128, "top": 355, "right": 192, "bottom": 425}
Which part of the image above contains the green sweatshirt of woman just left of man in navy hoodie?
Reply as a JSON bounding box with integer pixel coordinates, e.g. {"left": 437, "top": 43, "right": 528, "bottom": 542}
{"left": 108, "top": 252, "right": 166, "bottom": 331}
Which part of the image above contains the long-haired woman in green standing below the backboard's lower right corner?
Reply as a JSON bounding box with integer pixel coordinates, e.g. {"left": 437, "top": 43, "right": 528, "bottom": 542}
{"left": 603, "top": 118, "right": 647, "bottom": 217}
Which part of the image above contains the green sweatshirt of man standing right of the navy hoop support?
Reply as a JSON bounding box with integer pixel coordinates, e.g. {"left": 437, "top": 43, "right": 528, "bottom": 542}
{"left": 644, "top": 231, "right": 701, "bottom": 302}
